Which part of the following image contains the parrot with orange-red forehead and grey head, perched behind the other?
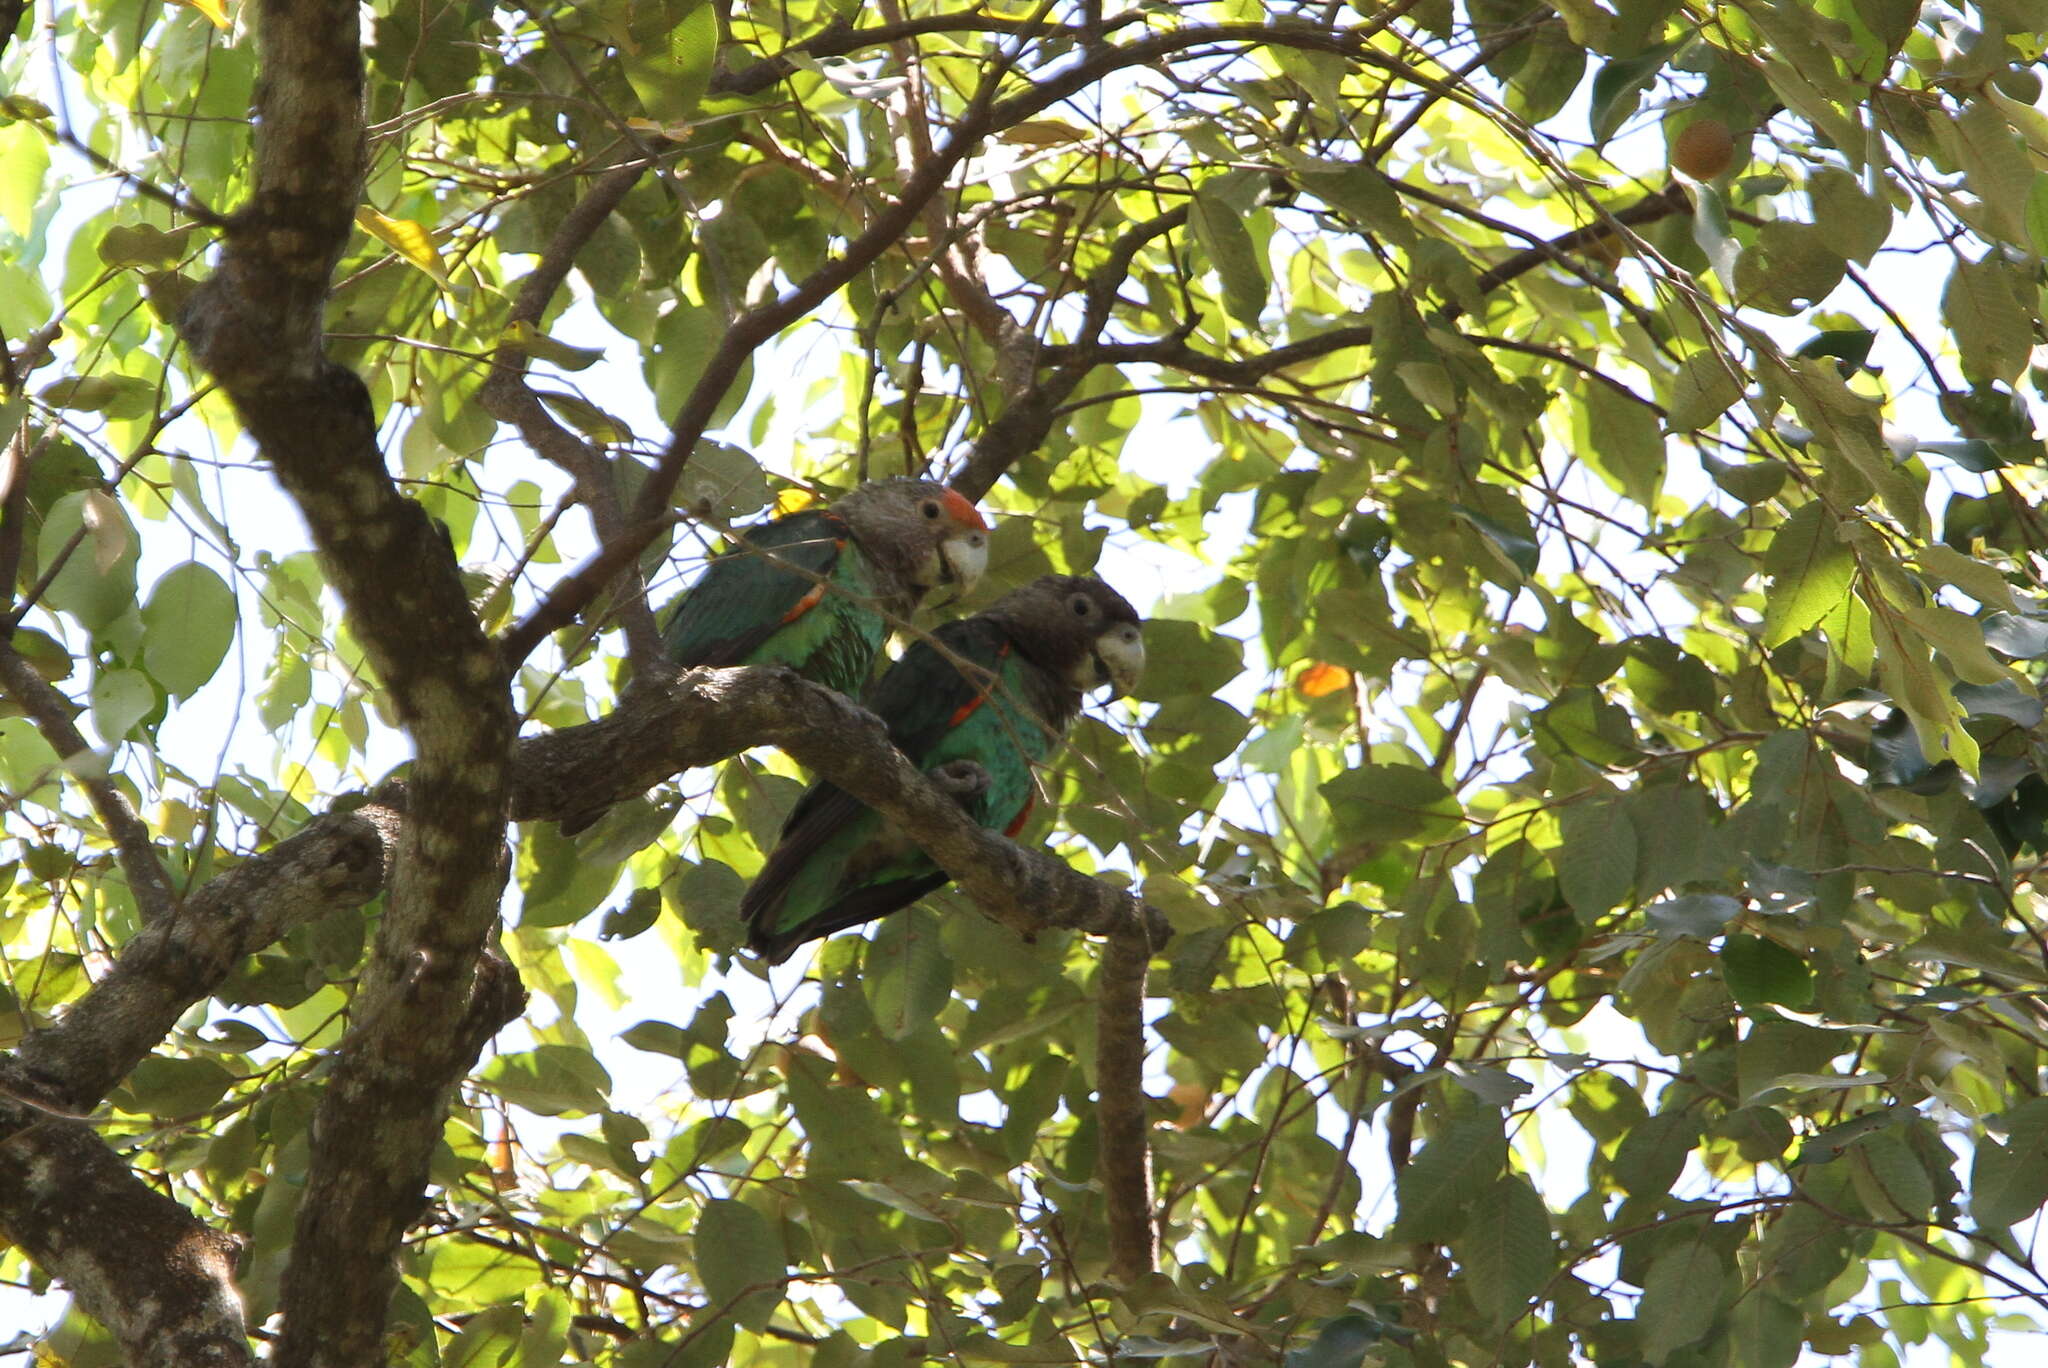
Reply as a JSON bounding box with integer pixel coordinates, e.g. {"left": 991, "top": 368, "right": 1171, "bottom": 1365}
{"left": 662, "top": 479, "right": 989, "bottom": 694}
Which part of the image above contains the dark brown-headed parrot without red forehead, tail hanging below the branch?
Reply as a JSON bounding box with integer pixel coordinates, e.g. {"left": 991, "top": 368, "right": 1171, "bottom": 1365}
{"left": 739, "top": 575, "right": 1145, "bottom": 963}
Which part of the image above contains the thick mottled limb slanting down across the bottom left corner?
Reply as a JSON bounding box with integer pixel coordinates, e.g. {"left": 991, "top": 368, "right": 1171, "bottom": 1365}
{"left": 0, "top": 1102, "right": 250, "bottom": 1368}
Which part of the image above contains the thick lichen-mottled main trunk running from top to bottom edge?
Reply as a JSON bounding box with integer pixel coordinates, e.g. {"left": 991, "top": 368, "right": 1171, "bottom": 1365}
{"left": 180, "top": 0, "right": 516, "bottom": 1368}
